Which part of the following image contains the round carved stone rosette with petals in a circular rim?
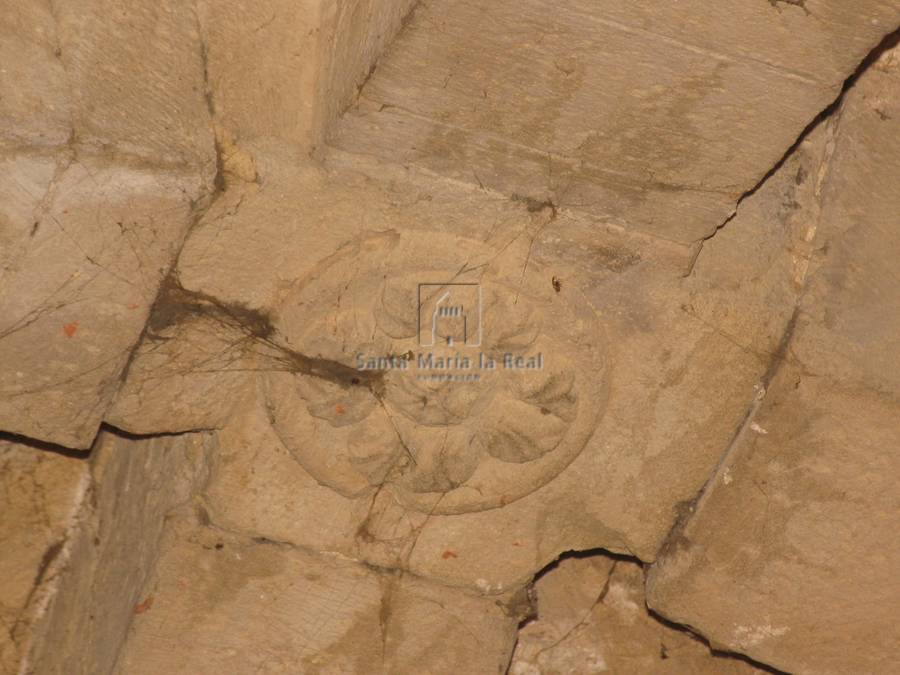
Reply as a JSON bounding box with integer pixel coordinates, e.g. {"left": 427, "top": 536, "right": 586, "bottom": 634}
{"left": 265, "top": 232, "right": 606, "bottom": 514}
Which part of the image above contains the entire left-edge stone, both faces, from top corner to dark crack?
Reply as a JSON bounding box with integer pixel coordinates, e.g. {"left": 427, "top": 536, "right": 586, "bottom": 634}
{"left": 0, "top": 0, "right": 215, "bottom": 448}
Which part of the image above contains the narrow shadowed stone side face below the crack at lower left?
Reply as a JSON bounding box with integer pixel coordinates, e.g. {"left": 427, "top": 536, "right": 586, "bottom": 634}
{"left": 22, "top": 432, "right": 213, "bottom": 675}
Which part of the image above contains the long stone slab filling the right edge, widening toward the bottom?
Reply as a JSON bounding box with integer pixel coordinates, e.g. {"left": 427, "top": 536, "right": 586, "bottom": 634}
{"left": 648, "top": 43, "right": 900, "bottom": 673}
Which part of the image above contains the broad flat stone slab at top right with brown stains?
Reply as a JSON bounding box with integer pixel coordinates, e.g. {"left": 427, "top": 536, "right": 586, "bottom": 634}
{"left": 334, "top": 0, "right": 900, "bottom": 242}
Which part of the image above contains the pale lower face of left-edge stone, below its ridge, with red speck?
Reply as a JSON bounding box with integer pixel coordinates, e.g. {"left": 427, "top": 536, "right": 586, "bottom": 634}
{"left": 0, "top": 155, "right": 201, "bottom": 448}
